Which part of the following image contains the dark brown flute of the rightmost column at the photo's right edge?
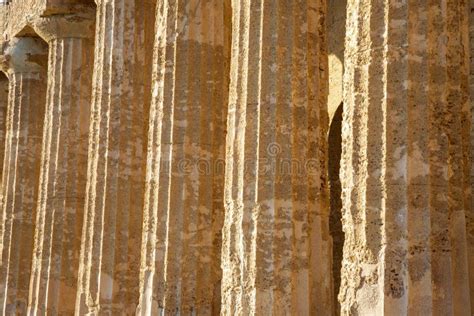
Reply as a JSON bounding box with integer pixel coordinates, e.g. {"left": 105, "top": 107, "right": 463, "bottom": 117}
{"left": 446, "top": 0, "right": 471, "bottom": 315}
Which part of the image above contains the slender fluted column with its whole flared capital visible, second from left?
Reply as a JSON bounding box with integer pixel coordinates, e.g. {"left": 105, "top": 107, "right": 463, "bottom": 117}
{"left": 29, "top": 10, "right": 94, "bottom": 314}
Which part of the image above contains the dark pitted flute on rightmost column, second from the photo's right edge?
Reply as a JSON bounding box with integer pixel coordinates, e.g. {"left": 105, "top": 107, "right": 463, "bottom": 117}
{"left": 428, "top": 1, "right": 453, "bottom": 314}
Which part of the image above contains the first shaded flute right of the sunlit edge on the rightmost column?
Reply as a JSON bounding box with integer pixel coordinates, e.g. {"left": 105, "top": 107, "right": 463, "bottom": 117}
{"left": 384, "top": 1, "right": 410, "bottom": 314}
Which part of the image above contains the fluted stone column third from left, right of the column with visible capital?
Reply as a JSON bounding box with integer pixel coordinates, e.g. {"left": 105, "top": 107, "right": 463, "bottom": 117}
{"left": 76, "top": 0, "right": 155, "bottom": 315}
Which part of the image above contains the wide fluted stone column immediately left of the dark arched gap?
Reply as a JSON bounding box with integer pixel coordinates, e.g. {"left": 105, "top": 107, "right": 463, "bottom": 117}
{"left": 222, "top": 0, "right": 333, "bottom": 315}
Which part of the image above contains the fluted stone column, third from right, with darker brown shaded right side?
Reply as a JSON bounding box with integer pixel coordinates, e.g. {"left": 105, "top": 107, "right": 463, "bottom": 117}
{"left": 138, "top": 0, "right": 230, "bottom": 315}
